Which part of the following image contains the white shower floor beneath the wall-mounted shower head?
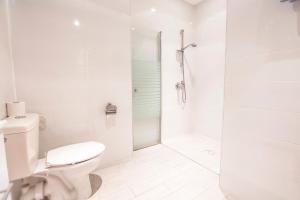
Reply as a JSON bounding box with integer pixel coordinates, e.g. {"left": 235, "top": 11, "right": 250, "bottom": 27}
{"left": 165, "top": 133, "right": 221, "bottom": 174}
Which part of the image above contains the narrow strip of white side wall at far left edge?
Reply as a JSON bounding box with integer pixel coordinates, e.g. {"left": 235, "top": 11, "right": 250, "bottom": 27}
{"left": 0, "top": 0, "right": 14, "bottom": 120}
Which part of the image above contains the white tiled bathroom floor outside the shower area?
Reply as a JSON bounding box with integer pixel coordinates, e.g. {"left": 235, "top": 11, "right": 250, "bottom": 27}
{"left": 96, "top": 145, "right": 224, "bottom": 200}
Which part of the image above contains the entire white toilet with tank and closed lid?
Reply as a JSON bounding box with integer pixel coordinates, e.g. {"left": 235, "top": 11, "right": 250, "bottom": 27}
{"left": 1, "top": 114, "right": 105, "bottom": 200}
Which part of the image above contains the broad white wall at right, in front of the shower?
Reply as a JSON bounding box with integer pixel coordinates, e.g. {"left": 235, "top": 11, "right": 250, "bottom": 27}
{"left": 221, "top": 0, "right": 300, "bottom": 200}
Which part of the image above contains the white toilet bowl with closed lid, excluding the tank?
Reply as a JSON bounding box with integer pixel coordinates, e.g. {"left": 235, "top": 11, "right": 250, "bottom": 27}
{"left": 32, "top": 142, "right": 105, "bottom": 200}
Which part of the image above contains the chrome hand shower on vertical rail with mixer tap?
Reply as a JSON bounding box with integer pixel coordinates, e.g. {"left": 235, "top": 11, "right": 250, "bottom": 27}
{"left": 176, "top": 30, "right": 197, "bottom": 104}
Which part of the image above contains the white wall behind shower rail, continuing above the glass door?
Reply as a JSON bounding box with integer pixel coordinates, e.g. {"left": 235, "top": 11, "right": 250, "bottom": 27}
{"left": 132, "top": 0, "right": 194, "bottom": 141}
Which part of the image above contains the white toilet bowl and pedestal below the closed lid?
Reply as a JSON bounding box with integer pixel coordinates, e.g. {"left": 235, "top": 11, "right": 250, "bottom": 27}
{"left": 22, "top": 156, "right": 102, "bottom": 200}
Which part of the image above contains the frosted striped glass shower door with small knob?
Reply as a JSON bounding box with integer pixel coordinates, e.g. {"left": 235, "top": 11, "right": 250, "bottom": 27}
{"left": 132, "top": 30, "right": 161, "bottom": 150}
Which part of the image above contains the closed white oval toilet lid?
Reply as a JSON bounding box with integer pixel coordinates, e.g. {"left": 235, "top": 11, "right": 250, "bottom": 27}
{"left": 46, "top": 142, "right": 105, "bottom": 167}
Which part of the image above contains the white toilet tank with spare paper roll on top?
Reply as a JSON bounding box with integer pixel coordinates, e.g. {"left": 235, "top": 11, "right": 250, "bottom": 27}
{"left": 0, "top": 114, "right": 39, "bottom": 181}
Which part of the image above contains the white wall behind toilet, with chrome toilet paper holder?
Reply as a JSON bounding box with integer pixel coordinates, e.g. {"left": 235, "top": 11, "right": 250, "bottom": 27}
{"left": 11, "top": 0, "right": 132, "bottom": 165}
